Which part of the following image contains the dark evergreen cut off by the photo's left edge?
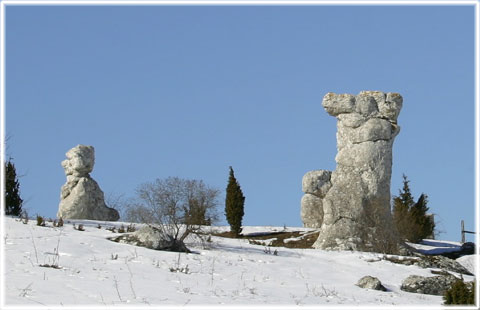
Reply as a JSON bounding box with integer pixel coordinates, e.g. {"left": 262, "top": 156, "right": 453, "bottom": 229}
{"left": 5, "top": 159, "right": 23, "bottom": 216}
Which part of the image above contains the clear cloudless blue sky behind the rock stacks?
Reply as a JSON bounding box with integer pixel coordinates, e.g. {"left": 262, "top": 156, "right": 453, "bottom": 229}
{"left": 5, "top": 6, "right": 475, "bottom": 240}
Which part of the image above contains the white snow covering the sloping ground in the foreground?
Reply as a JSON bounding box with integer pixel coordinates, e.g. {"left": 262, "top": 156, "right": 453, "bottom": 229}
{"left": 2, "top": 218, "right": 473, "bottom": 306}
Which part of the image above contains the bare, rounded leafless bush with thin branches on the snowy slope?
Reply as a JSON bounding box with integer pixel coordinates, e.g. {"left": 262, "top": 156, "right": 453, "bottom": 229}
{"left": 125, "top": 177, "right": 219, "bottom": 250}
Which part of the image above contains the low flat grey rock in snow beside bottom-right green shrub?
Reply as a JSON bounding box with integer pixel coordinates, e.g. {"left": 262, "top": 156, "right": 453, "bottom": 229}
{"left": 400, "top": 275, "right": 458, "bottom": 296}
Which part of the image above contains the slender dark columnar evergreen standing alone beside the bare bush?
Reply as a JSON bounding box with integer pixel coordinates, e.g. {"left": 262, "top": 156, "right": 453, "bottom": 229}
{"left": 225, "top": 167, "right": 245, "bottom": 237}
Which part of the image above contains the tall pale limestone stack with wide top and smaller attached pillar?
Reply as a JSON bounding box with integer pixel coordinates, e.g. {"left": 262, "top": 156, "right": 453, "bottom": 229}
{"left": 301, "top": 91, "right": 402, "bottom": 250}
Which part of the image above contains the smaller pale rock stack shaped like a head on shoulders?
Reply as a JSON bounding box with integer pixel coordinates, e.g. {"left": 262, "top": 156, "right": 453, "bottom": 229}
{"left": 57, "top": 145, "right": 120, "bottom": 221}
